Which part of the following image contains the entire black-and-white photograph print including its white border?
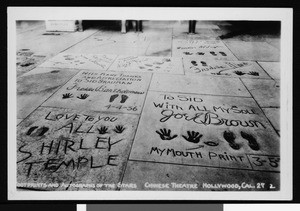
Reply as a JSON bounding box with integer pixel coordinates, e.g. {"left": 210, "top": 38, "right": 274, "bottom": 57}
{"left": 8, "top": 8, "right": 292, "bottom": 200}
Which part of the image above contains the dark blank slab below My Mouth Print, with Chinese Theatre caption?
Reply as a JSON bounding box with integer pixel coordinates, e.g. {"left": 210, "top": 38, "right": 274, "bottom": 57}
{"left": 121, "top": 161, "right": 280, "bottom": 191}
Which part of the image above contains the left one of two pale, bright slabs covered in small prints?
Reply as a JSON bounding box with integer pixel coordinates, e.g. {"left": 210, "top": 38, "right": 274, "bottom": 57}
{"left": 40, "top": 53, "right": 117, "bottom": 70}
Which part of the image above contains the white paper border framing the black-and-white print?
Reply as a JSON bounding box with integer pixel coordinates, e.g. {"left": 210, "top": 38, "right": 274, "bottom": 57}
{"left": 7, "top": 7, "right": 293, "bottom": 201}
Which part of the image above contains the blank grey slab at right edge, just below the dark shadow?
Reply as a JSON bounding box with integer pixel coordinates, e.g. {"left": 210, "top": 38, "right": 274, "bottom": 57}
{"left": 224, "top": 41, "right": 280, "bottom": 62}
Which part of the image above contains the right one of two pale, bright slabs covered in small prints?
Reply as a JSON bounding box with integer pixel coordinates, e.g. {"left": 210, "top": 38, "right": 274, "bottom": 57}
{"left": 109, "top": 56, "right": 184, "bottom": 75}
